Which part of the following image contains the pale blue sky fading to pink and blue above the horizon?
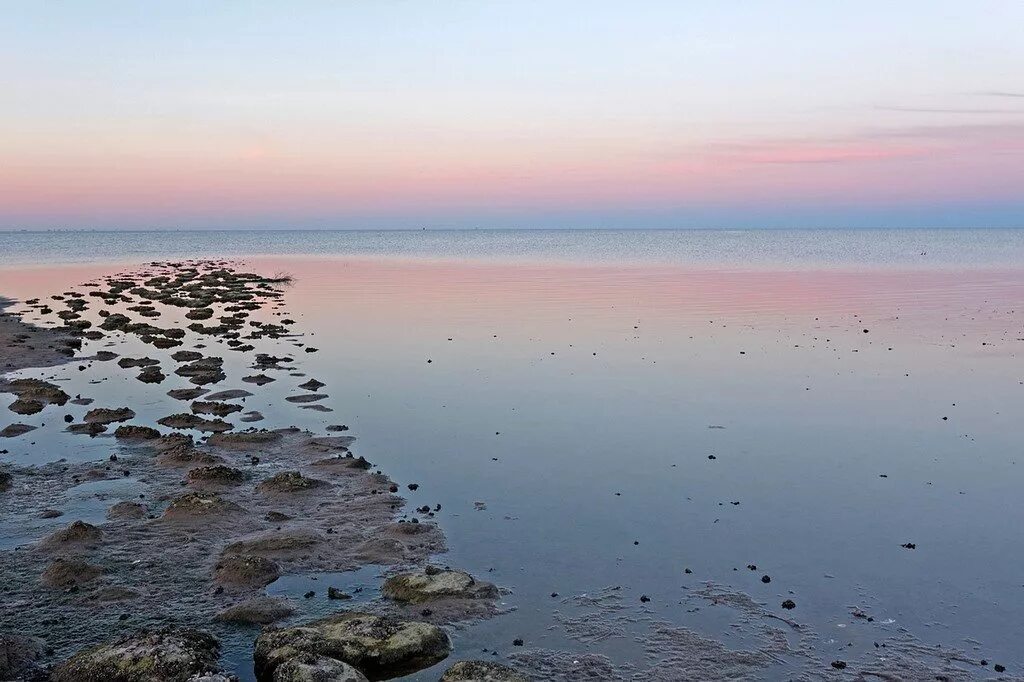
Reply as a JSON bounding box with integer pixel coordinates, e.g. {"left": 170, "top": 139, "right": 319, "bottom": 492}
{"left": 0, "top": 0, "right": 1024, "bottom": 229}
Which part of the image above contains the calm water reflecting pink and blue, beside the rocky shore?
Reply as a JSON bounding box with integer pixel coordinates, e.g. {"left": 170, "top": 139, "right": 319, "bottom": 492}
{"left": 0, "top": 230, "right": 1024, "bottom": 680}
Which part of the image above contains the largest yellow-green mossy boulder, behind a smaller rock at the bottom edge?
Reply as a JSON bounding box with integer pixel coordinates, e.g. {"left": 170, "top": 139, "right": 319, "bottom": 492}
{"left": 254, "top": 611, "right": 452, "bottom": 682}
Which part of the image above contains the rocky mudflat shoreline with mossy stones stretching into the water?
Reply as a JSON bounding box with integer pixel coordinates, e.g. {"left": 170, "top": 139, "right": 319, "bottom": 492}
{"left": 0, "top": 261, "right": 526, "bottom": 682}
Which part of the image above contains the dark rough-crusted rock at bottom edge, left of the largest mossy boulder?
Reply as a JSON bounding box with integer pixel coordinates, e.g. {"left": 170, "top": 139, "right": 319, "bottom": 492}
{"left": 52, "top": 628, "right": 220, "bottom": 682}
